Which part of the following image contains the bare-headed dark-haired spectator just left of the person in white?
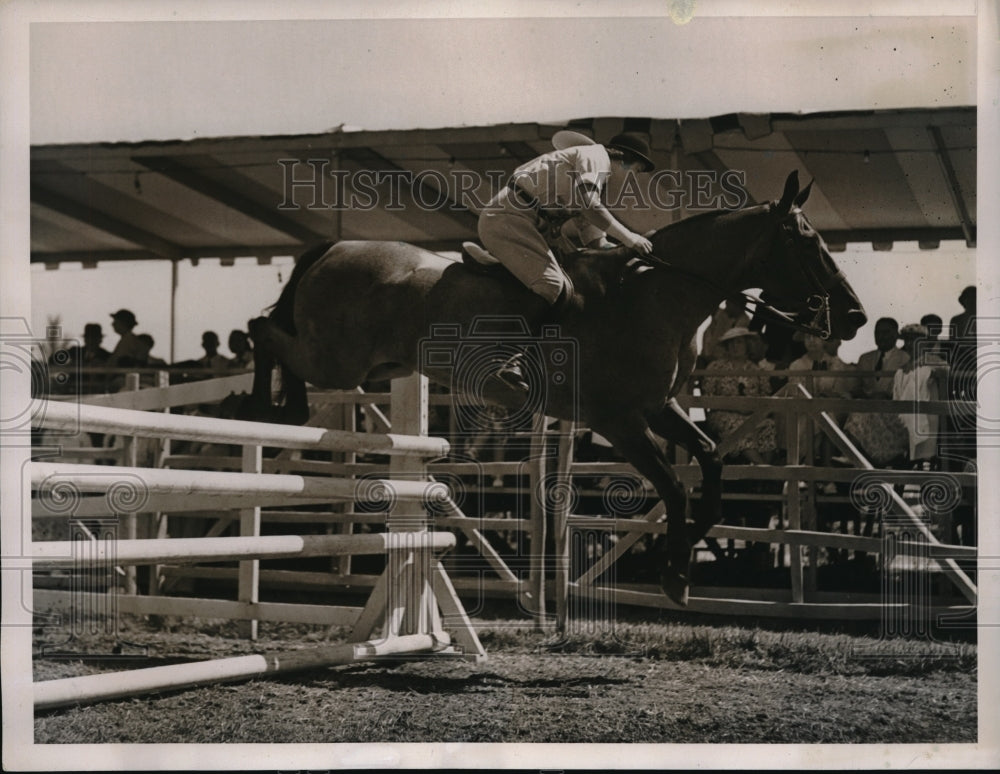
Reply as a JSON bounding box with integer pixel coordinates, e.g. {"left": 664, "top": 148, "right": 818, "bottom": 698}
{"left": 844, "top": 317, "right": 910, "bottom": 467}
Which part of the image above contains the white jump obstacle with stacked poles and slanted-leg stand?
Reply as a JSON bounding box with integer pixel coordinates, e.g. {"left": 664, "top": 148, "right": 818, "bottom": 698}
{"left": 30, "top": 382, "right": 485, "bottom": 710}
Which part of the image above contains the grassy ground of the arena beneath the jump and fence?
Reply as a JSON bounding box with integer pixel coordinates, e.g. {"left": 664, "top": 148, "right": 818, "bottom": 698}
{"left": 34, "top": 612, "right": 977, "bottom": 743}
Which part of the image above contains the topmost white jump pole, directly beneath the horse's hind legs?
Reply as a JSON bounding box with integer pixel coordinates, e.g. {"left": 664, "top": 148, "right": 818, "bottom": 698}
{"left": 32, "top": 401, "right": 450, "bottom": 457}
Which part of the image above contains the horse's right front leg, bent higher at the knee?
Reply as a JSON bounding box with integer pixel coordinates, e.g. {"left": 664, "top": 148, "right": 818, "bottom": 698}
{"left": 648, "top": 398, "right": 722, "bottom": 545}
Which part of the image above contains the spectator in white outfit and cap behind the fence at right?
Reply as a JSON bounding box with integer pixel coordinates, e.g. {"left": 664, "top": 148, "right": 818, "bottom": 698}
{"left": 892, "top": 325, "right": 948, "bottom": 469}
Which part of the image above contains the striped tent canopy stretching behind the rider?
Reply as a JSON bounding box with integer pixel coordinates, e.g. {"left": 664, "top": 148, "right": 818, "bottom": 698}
{"left": 31, "top": 108, "right": 976, "bottom": 264}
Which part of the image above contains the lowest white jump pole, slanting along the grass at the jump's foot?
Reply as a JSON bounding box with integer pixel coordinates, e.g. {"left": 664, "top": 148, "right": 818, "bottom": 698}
{"left": 34, "top": 632, "right": 451, "bottom": 710}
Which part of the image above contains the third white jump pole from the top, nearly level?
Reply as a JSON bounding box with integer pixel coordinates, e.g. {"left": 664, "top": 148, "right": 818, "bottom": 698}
{"left": 31, "top": 532, "right": 455, "bottom": 569}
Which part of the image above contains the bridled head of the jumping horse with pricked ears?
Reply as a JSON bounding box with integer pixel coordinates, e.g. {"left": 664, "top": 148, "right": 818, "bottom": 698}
{"left": 755, "top": 172, "right": 868, "bottom": 340}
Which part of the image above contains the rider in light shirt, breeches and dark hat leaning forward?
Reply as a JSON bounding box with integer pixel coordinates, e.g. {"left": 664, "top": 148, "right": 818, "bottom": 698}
{"left": 479, "top": 132, "right": 654, "bottom": 389}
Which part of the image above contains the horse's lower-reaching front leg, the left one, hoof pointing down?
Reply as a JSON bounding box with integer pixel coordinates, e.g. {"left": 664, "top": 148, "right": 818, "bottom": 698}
{"left": 591, "top": 415, "right": 691, "bottom": 606}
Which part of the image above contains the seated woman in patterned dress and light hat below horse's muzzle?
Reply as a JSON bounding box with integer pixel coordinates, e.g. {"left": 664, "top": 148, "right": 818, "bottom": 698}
{"left": 701, "top": 326, "right": 777, "bottom": 464}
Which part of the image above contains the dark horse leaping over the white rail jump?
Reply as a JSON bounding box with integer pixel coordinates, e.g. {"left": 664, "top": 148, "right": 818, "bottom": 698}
{"left": 244, "top": 172, "right": 867, "bottom": 606}
